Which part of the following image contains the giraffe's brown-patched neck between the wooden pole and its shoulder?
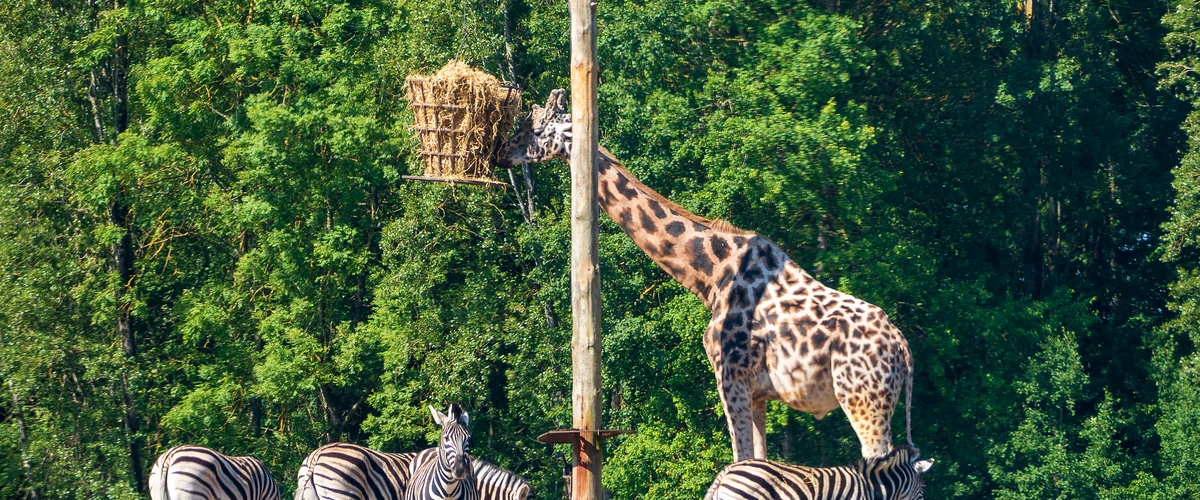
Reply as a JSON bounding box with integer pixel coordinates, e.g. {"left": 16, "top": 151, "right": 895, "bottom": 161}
{"left": 596, "top": 143, "right": 755, "bottom": 311}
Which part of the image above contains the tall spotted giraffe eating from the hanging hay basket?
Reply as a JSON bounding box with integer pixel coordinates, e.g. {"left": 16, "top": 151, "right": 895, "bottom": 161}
{"left": 499, "top": 89, "right": 912, "bottom": 462}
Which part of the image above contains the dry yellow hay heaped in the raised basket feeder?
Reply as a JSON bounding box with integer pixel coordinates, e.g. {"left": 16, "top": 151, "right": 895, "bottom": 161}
{"left": 407, "top": 60, "right": 521, "bottom": 182}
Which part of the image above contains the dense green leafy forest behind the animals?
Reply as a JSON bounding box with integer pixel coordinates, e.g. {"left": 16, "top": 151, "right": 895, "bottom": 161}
{"left": 0, "top": 0, "right": 1200, "bottom": 499}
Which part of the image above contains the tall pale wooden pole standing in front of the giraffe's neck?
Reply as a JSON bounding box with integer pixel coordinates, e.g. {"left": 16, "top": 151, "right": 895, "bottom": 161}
{"left": 569, "top": 0, "right": 602, "bottom": 500}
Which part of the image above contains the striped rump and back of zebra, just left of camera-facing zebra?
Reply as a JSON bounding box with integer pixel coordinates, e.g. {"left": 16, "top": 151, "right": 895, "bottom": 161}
{"left": 295, "top": 442, "right": 416, "bottom": 500}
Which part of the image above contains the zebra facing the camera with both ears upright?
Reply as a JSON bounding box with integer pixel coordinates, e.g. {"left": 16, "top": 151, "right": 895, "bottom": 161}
{"left": 404, "top": 403, "right": 479, "bottom": 500}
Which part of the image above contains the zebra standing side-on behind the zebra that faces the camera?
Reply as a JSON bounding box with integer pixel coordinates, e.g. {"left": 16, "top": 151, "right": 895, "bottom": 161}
{"left": 295, "top": 442, "right": 529, "bottom": 500}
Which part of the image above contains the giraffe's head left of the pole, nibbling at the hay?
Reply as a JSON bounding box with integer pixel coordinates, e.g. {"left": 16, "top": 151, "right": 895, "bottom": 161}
{"left": 498, "top": 89, "right": 571, "bottom": 168}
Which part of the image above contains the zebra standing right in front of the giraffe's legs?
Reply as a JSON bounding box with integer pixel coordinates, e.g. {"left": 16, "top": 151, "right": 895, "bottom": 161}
{"left": 704, "top": 445, "right": 934, "bottom": 500}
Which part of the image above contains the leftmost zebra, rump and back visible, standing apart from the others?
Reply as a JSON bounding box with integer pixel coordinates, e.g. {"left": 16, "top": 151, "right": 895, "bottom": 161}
{"left": 149, "top": 445, "right": 280, "bottom": 500}
